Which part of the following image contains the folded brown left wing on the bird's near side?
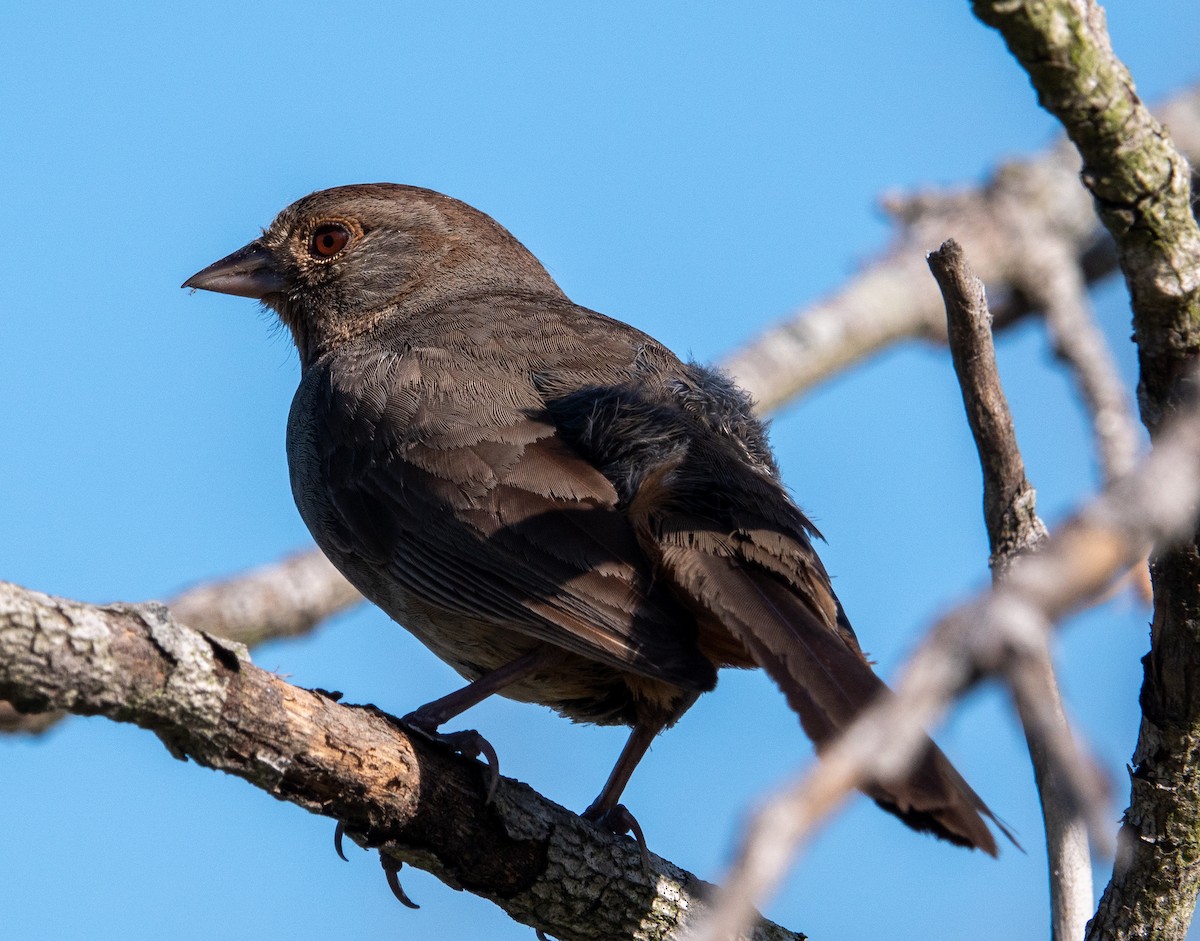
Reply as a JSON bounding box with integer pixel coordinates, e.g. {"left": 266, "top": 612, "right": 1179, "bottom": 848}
{"left": 317, "top": 352, "right": 716, "bottom": 690}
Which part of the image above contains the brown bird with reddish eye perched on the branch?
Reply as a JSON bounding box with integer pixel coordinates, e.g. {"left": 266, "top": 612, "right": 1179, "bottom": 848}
{"left": 184, "top": 184, "right": 996, "bottom": 855}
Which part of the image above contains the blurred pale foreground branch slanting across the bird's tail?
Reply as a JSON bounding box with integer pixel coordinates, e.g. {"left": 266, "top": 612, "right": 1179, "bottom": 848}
{"left": 691, "top": 379, "right": 1200, "bottom": 941}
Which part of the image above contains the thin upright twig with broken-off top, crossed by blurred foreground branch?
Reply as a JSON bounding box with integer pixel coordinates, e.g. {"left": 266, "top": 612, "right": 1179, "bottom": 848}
{"left": 929, "top": 240, "right": 1089, "bottom": 941}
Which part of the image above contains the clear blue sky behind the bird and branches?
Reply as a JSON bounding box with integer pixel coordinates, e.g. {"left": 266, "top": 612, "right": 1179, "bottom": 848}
{"left": 0, "top": 0, "right": 1200, "bottom": 940}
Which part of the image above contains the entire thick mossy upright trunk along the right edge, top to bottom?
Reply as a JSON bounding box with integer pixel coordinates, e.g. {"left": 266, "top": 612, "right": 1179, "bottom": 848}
{"left": 974, "top": 0, "right": 1200, "bottom": 941}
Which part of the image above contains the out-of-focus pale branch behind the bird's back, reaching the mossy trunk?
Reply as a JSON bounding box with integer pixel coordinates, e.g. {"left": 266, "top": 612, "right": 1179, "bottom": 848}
{"left": 724, "top": 81, "right": 1200, "bottom": 415}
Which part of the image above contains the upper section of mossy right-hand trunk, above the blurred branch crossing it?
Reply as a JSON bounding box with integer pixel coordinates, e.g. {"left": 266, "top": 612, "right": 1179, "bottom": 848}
{"left": 974, "top": 0, "right": 1200, "bottom": 420}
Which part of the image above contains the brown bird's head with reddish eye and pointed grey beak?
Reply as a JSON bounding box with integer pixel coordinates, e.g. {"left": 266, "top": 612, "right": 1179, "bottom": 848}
{"left": 184, "top": 184, "right": 562, "bottom": 361}
